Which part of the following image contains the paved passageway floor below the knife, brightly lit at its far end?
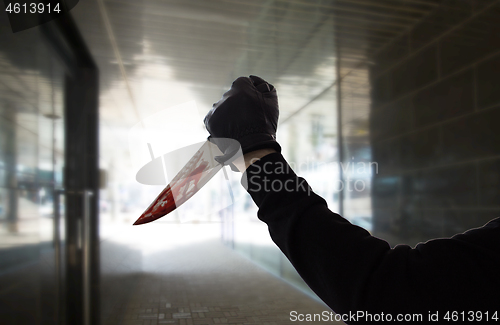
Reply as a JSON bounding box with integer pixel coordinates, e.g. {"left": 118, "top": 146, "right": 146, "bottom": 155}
{"left": 101, "top": 221, "right": 340, "bottom": 325}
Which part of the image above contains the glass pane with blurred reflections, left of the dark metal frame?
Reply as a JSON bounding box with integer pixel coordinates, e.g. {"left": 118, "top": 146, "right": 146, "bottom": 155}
{"left": 0, "top": 22, "right": 63, "bottom": 324}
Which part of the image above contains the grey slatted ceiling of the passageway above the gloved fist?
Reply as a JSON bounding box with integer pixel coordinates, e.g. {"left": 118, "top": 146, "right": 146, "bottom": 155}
{"left": 69, "top": 0, "right": 441, "bottom": 124}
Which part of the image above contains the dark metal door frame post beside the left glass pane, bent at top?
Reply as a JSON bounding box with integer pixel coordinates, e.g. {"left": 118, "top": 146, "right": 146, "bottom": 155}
{"left": 41, "top": 13, "right": 100, "bottom": 325}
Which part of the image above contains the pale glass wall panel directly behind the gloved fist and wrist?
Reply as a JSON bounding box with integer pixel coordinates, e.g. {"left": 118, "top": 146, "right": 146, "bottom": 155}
{"left": 228, "top": 12, "right": 340, "bottom": 294}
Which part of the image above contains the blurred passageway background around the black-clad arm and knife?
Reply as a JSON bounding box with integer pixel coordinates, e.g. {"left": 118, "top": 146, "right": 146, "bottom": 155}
{"left": 0, "top": 0, "right": 500, "bottom": 324}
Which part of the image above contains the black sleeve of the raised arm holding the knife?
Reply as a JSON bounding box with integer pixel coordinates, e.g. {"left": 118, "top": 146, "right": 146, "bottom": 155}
{"left": 242, "top": 153, "right": 500, "bottom": 321}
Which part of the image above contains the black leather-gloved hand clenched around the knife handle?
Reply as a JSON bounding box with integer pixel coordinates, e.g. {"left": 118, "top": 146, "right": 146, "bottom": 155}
{"left": 204, "top": 76, "right": 281, "bottom": 164}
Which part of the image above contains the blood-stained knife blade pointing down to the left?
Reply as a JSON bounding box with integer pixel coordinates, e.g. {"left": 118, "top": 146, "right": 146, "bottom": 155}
{"left": 134, "top": 140, "right": 241, "bottom": 225}
